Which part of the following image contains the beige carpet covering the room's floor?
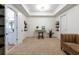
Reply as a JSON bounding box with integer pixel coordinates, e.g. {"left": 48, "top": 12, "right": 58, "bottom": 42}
{"left": 8, "top": 38, "right": 65, "bottom": 55}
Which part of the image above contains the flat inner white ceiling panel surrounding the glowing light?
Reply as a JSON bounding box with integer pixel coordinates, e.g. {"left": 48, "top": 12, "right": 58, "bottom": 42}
{"left": 25, "top": 4, "right": 59, "bottom": 13}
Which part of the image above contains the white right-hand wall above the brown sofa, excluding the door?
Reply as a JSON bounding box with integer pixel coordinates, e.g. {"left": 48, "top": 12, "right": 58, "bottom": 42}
{"left": 57, "top": 5, "right": 79, "bottom": 34}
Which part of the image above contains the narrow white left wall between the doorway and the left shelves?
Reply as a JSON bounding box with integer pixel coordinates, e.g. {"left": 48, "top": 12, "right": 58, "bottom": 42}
{"left": 18, "top": 12, "right": 26, "bottom": 43}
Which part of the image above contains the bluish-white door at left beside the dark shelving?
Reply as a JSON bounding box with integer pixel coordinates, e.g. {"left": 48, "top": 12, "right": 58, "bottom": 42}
{"left": 5, "top": 7, "right": 16, "bottom": 49}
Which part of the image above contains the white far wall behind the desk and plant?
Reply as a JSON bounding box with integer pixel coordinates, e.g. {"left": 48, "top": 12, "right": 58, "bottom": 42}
{"left": 26, "top": 17, "right": 56, "bottom": 37}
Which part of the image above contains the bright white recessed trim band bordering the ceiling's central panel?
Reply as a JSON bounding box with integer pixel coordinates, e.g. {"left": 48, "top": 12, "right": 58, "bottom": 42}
{"left": 22, "top": 4, "right": 76, "bottom": 16}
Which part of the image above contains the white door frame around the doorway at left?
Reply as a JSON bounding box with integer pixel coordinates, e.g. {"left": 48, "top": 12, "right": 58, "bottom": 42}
{"left": 5, "top": 5, "right": 18, "bottom": 54}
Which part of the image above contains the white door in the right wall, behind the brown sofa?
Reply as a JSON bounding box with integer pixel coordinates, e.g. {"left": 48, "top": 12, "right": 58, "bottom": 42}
{"left": 60, "top": 15, "right": 67, "bottom": 34}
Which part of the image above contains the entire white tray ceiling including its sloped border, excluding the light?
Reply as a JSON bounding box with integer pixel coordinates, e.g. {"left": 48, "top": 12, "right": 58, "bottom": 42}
{"left": 14, "top": 4, "right": 75, "bottom": 16}
